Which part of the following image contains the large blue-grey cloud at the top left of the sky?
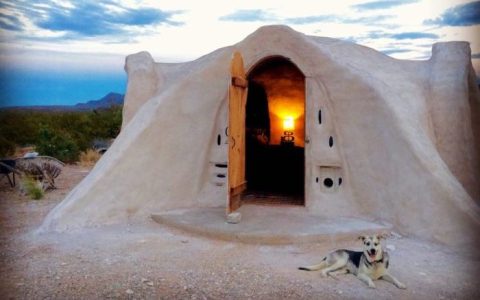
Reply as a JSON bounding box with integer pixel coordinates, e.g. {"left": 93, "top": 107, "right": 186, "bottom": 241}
{"left": 0, "top": 0, "right": 182, "bottom": 38}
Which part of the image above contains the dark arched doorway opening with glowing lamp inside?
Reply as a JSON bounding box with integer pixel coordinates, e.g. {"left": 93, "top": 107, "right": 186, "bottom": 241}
{"left": 243, "top": 57, "right": 305, "bottom": 205}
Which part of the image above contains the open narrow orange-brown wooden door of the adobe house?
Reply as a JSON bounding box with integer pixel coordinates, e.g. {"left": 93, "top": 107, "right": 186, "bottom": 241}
{"left": 227, "top": 51, "right": 248, "bottom": 214}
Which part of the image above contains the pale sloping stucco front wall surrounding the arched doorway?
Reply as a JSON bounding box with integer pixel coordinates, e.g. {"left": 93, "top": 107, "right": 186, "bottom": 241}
{"left": 42, "top": 26, "right": 479, "bottom": 243}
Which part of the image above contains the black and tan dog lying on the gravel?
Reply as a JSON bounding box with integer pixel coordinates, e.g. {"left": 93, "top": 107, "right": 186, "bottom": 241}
{"left": 298, "top": 235, "right": 406, "bottom": 289}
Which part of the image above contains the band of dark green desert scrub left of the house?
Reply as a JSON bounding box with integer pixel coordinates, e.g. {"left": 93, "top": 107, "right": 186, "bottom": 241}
{"left": 0, "top": 106, "right": 122, "bottom": 162}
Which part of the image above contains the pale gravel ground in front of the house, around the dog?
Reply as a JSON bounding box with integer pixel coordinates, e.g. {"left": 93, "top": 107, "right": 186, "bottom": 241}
{"left": 0, "top": 166, "right": 480, "bottom": 299}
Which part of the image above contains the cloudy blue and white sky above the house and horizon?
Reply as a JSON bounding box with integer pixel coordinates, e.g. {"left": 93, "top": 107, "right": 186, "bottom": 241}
{"left": 0, "top": 0, "right": 480, "bottom": 106}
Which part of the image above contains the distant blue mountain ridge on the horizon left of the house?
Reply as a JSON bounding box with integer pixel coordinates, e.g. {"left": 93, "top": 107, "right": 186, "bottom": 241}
{"left": 0, "top": 92, "right": 124, "bottom": 111}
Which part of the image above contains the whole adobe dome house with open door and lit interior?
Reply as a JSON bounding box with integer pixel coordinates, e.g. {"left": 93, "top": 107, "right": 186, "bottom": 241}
{"left": 42, "top": 26, "right": 480, "bottom": 244}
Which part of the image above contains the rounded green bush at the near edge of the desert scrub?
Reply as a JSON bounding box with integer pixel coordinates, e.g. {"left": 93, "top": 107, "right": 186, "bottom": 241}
{"left": 35, "top": 126, "right": 80, "bottom": 162}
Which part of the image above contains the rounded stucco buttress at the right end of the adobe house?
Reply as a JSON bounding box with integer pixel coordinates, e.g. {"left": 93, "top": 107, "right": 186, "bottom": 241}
{"left": 428, "top": 42, "right": 480, "bottom": 203}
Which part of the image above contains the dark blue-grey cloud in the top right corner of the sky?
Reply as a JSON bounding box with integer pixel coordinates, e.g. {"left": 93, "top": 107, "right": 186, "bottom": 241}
{"left": 424, "top": 1, "right": 480, "bottom": 26}
